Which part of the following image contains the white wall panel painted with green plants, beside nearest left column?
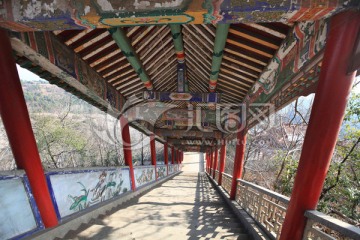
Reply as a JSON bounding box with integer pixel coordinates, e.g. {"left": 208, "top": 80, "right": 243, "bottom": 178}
{"left": 46, "top": 168, "right": 131, "bottom": 218}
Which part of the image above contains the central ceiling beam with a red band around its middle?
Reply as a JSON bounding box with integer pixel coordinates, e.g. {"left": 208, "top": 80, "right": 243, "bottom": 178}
{"left": 169, "top": 24, "right": 189, "bottom": 92}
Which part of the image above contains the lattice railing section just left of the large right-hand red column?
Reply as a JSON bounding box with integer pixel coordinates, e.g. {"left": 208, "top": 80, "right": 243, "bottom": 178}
{"left": 236, "top": 179, "right": 289, "bottom": 239}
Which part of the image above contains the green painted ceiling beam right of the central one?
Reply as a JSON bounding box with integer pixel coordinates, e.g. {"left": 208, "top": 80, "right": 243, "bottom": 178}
{"left": 209, "top": 24, "right": 230, "bottom": 92}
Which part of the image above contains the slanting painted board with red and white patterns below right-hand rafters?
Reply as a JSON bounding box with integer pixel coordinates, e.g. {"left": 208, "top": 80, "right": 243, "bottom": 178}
{"left": 245, "top": 20, "right": 328, "bottom": 107}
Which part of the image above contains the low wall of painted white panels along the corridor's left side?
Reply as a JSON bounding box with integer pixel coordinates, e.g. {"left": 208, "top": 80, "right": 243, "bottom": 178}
{"left": 0, "top": 164, "right": 179, "bottom": 240}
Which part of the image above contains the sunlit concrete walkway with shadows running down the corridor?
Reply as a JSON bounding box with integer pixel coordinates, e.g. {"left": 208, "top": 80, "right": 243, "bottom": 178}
{"left": 64, "top": 155, "right": 250, "bottom": 240}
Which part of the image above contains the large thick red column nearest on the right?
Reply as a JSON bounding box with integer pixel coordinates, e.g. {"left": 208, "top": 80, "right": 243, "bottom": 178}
{"left": 280, "top": 12, "right": 360, "bottom": 240}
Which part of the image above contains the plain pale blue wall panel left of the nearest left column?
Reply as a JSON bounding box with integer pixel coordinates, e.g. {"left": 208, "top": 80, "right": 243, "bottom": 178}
{"left": 0, "top": 174, "right": 43, "bottom": 239}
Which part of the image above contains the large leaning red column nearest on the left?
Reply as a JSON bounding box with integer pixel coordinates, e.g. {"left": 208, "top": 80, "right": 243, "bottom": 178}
{"left": 0, "top": 29, "right": 58, "bottom": 227}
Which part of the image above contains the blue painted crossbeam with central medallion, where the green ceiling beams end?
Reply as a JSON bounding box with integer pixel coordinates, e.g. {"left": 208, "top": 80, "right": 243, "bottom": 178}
{"left": 143, "top": 91, "right": 221, "bottom": 103}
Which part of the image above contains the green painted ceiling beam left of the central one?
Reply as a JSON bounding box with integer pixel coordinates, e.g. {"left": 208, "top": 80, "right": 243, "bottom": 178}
{"left": 109, "top": 28, "right": 153, "bottom": 91}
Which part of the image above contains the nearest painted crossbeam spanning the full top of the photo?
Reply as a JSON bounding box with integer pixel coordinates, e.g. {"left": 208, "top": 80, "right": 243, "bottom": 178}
{"left": 0, "top": 0, "right": 359, "bottom": 31}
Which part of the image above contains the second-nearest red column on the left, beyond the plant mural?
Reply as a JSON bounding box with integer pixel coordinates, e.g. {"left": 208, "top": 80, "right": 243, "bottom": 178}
{"left": 120, "top": 116, "right": 136, "bottom": 191}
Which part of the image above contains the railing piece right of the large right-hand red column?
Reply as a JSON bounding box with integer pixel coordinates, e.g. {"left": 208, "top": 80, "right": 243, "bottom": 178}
{"left": 303, "top": 211, "right": 360, "bottom": 240}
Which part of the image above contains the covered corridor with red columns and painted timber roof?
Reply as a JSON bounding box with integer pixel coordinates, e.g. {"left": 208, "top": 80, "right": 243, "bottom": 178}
{"left": 0, "top": 0, "right": 360, "bottom": 240}
